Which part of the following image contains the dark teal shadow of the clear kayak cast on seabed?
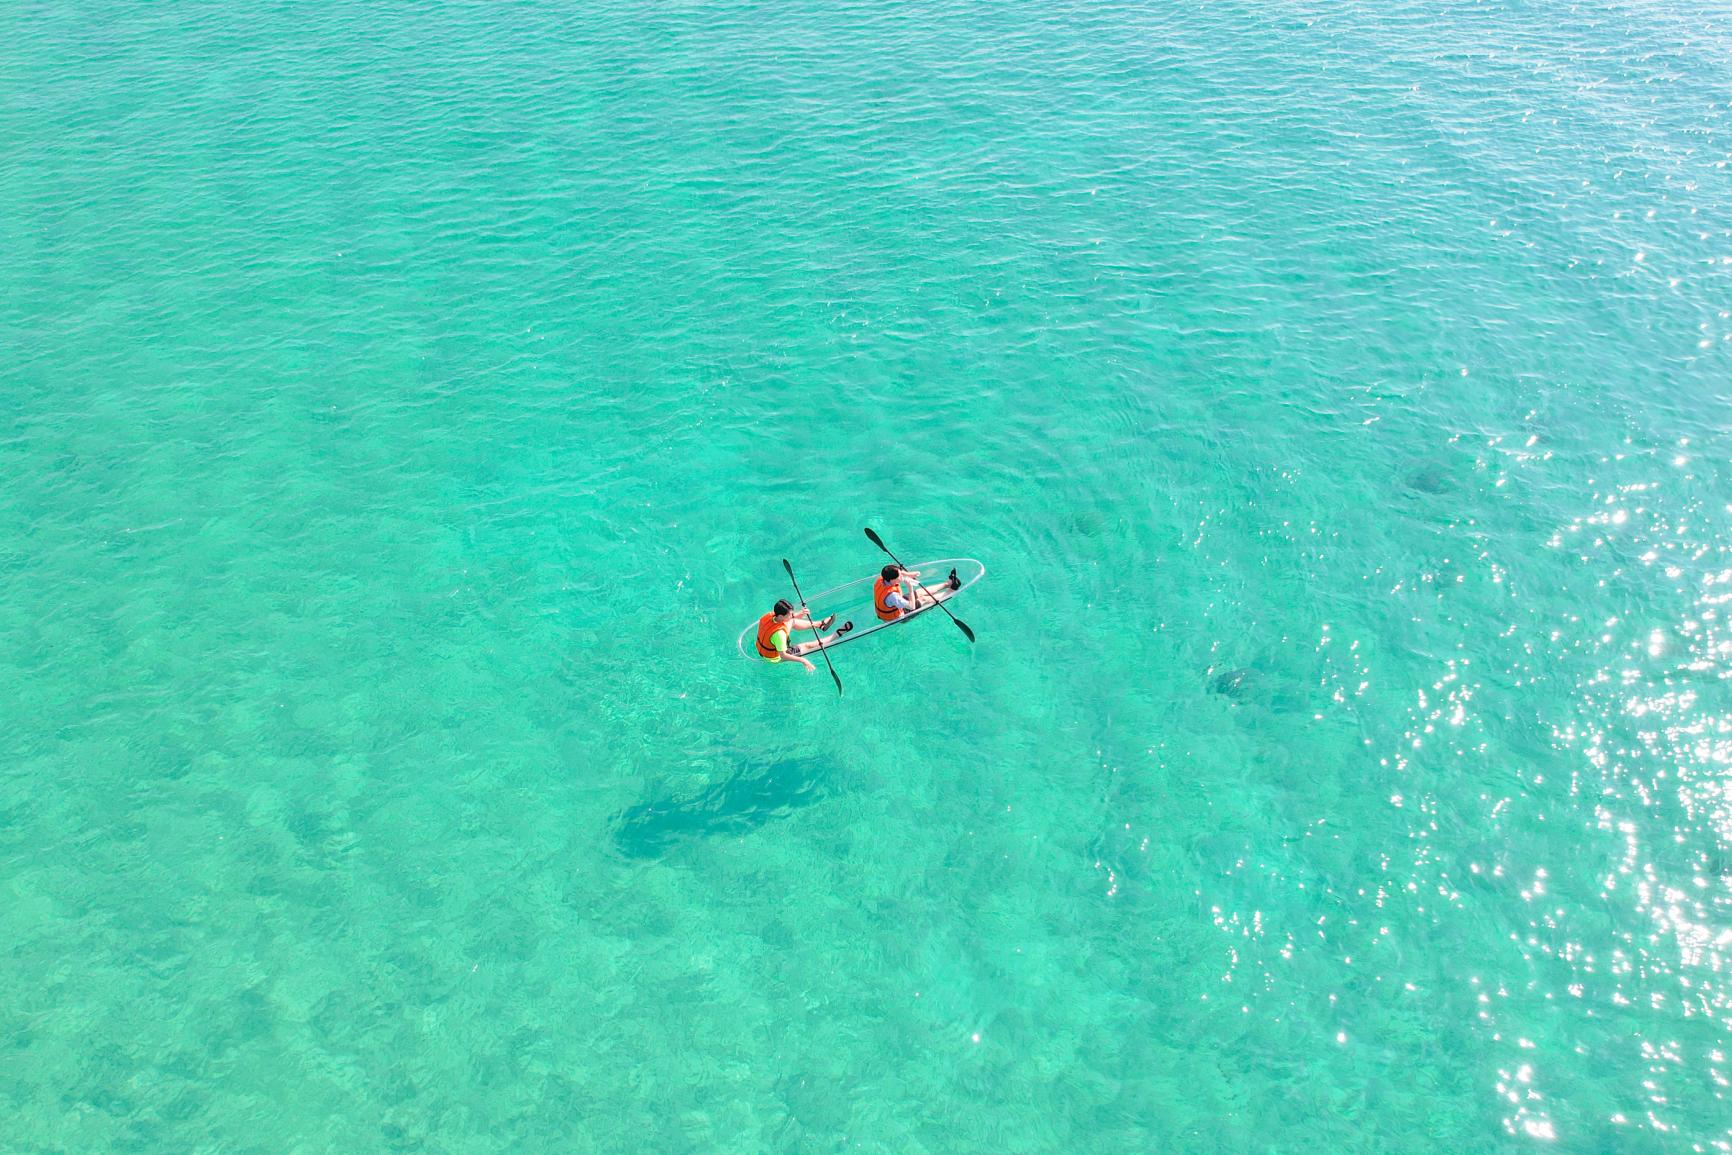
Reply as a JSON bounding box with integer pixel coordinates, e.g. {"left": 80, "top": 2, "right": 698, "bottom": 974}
{"left": 613, "top": 758, "right": 828, "bottom": 859}
